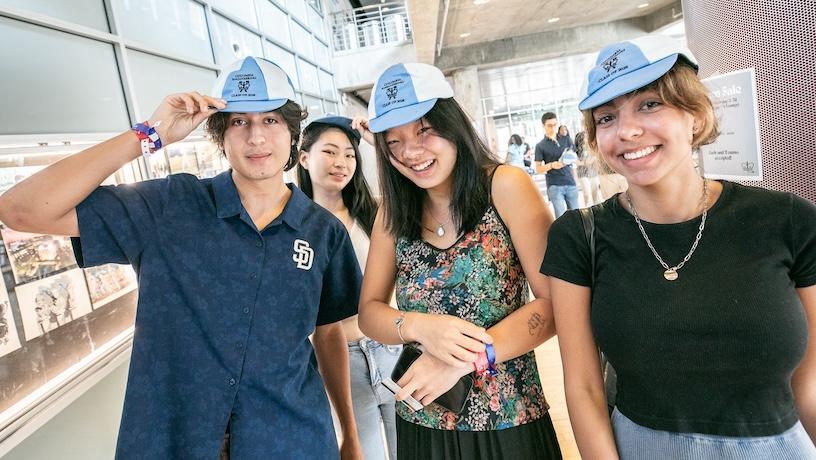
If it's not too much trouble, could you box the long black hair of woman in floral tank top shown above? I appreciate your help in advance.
[374,98,499,239]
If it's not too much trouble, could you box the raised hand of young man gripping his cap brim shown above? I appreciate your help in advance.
[149,91,226,145]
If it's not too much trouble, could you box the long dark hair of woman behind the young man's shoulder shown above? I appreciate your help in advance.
[297,123,377,237]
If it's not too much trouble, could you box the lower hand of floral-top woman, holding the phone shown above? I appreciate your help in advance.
[395,353,473,406]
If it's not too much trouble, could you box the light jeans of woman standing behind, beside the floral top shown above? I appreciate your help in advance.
[349,337,402,460]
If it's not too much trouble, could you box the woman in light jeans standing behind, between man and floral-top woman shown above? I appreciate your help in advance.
[297,116,402,460]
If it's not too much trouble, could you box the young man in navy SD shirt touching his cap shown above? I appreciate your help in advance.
[0,58,362,460]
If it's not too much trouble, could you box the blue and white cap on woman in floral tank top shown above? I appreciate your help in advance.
[368,63,453,133]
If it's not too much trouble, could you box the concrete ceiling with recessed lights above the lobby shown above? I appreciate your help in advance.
[408,0,682,71]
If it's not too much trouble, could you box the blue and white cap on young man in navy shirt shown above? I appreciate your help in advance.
[212,56,295,113]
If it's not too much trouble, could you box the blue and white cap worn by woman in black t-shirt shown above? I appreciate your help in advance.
[578,35,698,110]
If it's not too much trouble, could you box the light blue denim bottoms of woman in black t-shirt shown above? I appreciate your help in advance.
[612,409,816,460]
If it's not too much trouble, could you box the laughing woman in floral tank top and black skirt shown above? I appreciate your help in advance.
[360,64,561,460]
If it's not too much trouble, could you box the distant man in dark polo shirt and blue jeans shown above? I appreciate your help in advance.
[535,112,578,219]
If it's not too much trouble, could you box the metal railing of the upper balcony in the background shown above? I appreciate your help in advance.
[329,2,412,52]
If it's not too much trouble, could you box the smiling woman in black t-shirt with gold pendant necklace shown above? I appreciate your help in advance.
[541,36,816,460]
